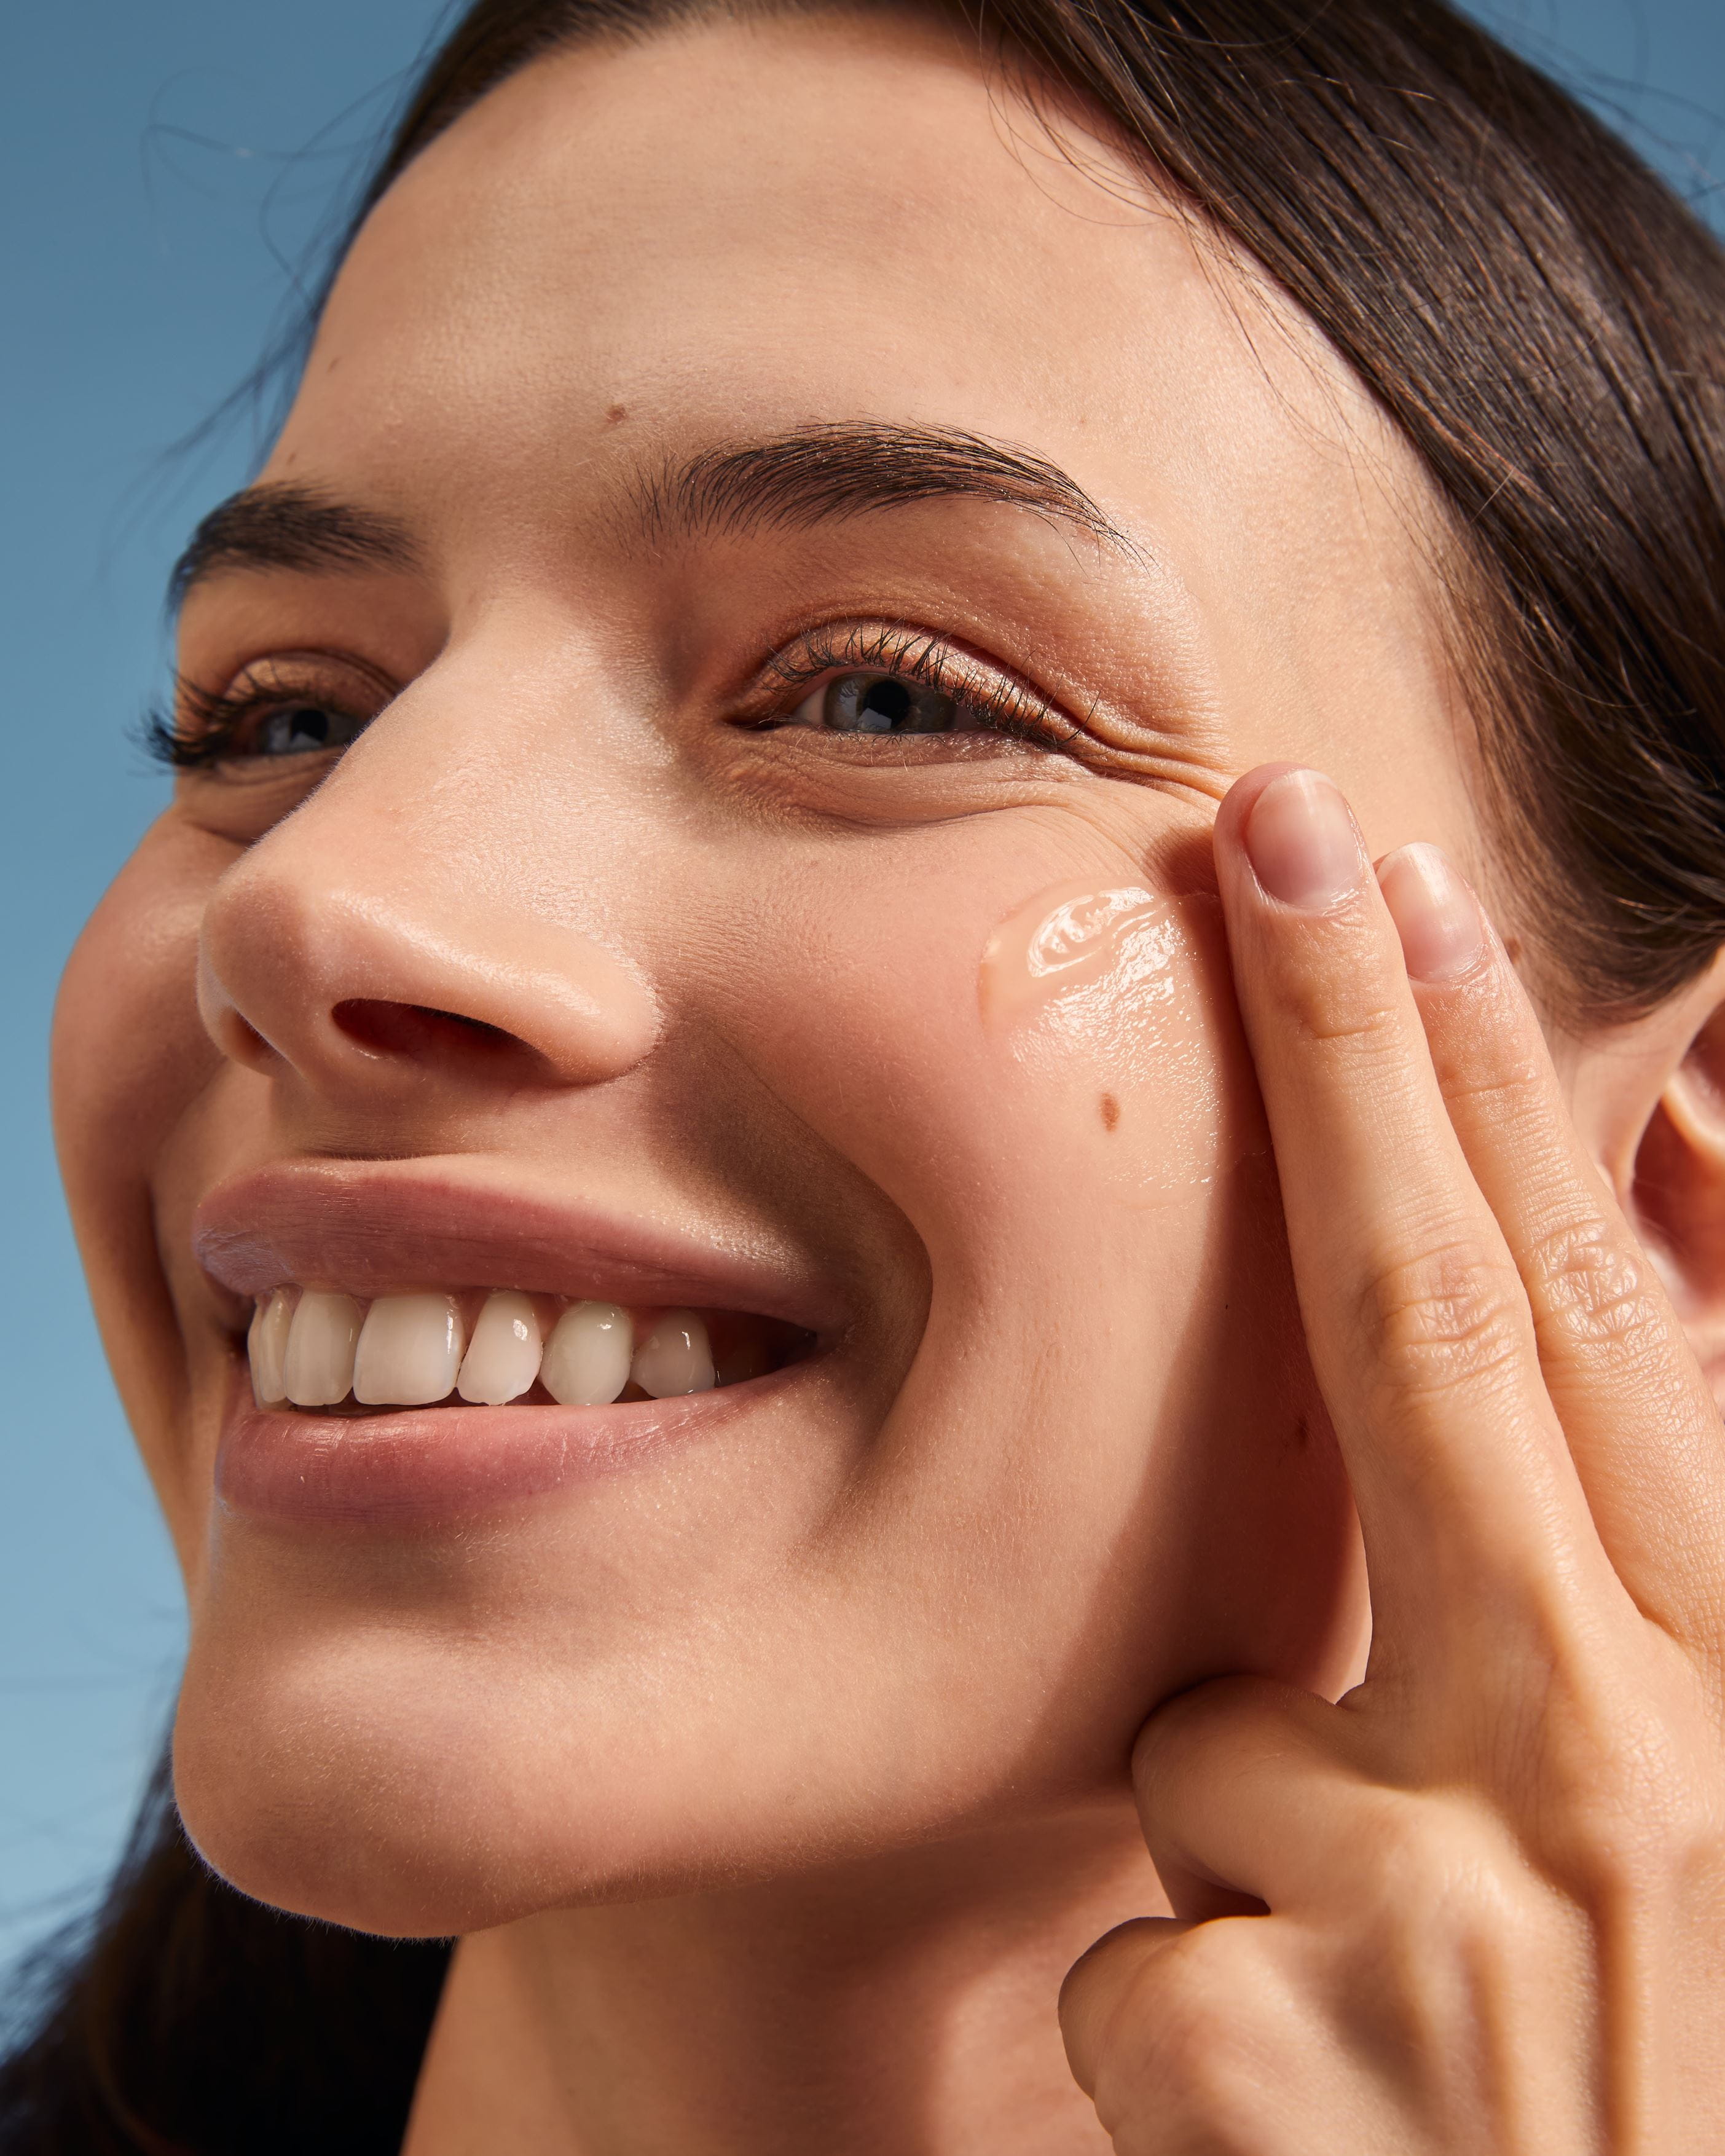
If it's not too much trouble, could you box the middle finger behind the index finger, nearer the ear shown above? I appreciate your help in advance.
[1378,845,1725,1641]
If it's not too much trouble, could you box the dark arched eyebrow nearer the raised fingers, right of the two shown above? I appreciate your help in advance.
[634,423,1139,559]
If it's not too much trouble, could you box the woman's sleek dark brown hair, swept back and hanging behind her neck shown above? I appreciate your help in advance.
[0,0,1725,2156]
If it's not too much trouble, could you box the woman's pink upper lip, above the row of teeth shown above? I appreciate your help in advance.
[192,1160,845,1332]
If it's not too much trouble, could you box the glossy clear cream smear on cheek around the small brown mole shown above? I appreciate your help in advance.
[976,884,1270,1205]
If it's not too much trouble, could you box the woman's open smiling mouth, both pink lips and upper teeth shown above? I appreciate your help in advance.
[192,1162,843,1522]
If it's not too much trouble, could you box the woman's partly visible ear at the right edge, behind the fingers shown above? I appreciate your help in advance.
[1565,951,1725,1406]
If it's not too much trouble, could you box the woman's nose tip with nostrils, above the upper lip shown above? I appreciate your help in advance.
[198,772,658,1106]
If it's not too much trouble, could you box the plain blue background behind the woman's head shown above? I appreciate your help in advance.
[0,0,1725,1960]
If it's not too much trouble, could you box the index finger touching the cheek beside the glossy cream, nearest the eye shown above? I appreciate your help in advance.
[1216,768,1609,1660]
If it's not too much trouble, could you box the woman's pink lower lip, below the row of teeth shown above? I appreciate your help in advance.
[216,1363,806,1527]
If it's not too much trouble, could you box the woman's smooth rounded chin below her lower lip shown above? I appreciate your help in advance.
[175,1624,910,1938]
